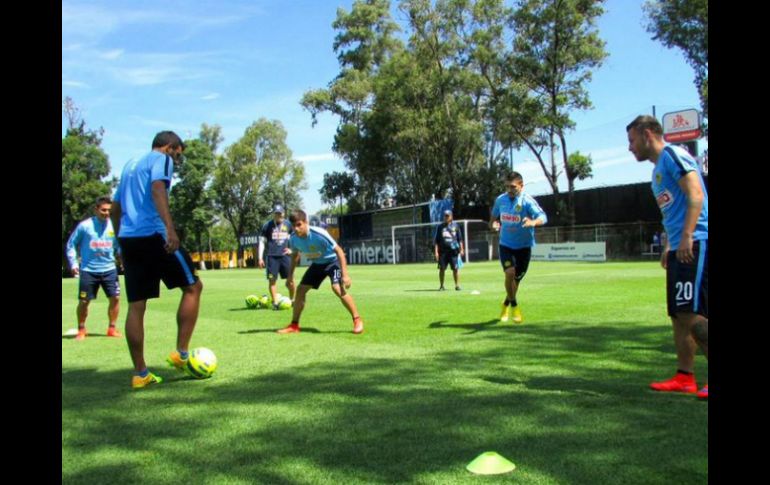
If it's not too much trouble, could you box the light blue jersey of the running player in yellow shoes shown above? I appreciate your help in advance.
[492,192,548,249]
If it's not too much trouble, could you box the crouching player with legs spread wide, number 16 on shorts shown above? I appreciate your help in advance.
[277,210,364,334]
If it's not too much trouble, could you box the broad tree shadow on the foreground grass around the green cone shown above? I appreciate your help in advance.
[62,322,708,484]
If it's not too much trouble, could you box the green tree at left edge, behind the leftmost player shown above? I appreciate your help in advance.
[61,97,116,266]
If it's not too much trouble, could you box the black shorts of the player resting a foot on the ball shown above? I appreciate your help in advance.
[118,234,198,302]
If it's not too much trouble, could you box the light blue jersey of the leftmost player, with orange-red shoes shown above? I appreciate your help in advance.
[67,216,119,273]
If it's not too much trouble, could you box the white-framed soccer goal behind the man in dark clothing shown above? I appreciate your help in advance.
[390,219,493,264]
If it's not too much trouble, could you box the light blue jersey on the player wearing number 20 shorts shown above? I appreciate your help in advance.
[652,145,709,250]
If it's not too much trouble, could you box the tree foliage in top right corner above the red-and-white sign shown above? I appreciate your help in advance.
[643,0,709,118]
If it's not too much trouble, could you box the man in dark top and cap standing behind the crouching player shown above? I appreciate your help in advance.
[257,204,296,310]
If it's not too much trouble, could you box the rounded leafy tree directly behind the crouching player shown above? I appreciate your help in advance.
[213,118,307,264]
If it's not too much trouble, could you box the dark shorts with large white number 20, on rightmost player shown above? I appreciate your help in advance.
[666,240,709,318]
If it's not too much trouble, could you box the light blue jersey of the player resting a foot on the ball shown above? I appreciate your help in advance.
[115,150,174,238]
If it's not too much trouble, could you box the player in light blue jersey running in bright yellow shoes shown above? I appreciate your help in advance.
[492,172,548,323]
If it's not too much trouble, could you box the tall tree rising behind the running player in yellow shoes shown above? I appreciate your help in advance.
[513,0,607,225]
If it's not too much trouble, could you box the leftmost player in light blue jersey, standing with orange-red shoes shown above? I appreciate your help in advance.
[67,197,122,340]
